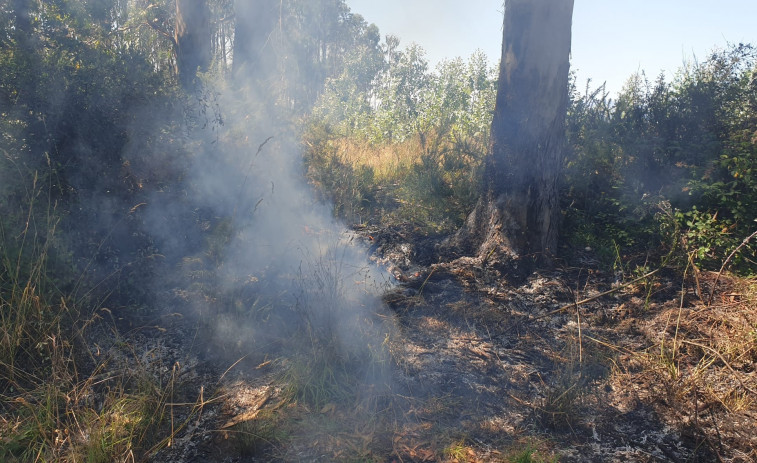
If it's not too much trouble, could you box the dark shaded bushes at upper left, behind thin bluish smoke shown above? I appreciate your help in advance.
[0,0,199,312]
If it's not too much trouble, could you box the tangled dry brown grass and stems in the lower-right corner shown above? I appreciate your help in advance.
[615,274,757,462]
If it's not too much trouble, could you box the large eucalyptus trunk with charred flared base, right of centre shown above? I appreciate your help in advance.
[452,0,573,268]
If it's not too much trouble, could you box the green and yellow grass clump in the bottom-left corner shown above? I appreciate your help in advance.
[0,300,167,462]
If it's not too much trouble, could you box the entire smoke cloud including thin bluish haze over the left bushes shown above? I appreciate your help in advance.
[0,0,392,442]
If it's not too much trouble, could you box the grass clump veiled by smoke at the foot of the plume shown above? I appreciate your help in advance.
[282,241,393,408]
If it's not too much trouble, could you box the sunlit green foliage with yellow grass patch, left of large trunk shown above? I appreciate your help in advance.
[305,47,496,232]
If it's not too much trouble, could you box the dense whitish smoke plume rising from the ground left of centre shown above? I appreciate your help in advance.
[132,2,392,398]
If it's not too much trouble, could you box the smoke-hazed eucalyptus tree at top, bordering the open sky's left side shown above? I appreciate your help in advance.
[232,0,380,112]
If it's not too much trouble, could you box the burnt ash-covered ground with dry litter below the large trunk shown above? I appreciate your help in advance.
[99,224,757,463]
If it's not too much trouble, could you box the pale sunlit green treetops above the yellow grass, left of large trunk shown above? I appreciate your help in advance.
[312,44,496,145]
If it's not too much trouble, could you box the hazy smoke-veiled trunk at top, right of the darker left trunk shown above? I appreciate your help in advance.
[231,0,281,84]
